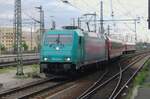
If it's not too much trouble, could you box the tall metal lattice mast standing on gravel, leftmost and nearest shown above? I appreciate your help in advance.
[14,0,24,75]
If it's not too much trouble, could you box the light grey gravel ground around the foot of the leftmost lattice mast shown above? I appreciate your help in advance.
[0,66,40,92]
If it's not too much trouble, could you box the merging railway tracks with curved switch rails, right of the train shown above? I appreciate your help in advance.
[77,54,149,99]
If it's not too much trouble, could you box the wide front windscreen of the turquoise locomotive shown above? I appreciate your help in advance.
[44,34,73,44]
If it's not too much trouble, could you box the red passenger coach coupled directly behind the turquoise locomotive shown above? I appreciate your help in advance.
[107,38,124,59]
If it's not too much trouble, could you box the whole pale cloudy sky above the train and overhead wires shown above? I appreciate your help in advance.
[0,0,150,42]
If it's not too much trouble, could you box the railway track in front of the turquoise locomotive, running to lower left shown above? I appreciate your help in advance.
[0,77,70,99]
